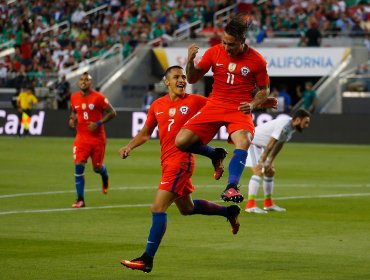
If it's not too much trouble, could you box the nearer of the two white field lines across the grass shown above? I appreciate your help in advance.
[0,193,370,215]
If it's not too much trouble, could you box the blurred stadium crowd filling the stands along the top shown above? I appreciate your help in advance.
[0,0,370,106]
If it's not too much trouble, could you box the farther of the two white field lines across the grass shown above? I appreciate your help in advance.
[0,183,370,199]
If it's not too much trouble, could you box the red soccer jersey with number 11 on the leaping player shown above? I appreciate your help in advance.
[197,44,270,106]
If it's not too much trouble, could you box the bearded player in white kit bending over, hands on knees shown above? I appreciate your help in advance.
[245,109,311,214]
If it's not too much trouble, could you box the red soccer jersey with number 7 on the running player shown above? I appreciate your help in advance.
[145,94,207,168]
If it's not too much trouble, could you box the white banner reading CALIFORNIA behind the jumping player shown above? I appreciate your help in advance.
[158,48,347,77]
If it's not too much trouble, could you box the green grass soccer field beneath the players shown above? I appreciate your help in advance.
[0,137,370,280]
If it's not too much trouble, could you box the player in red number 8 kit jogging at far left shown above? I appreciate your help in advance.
[69,72,116,208]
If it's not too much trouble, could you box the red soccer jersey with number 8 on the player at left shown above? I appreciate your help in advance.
[71,90,109,143]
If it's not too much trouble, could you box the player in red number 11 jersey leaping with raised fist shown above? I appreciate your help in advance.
[176,14,276,203]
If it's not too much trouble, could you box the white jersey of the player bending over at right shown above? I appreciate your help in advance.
[252,117,295,147]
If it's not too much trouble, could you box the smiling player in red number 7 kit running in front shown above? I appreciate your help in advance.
[119,66,240,273]
